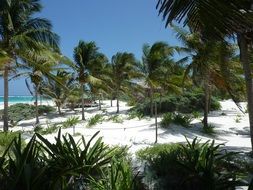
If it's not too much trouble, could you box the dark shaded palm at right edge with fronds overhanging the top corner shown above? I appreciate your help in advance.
[157,0,253,150]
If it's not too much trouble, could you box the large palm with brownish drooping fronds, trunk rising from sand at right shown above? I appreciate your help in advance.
[174,27,244,127]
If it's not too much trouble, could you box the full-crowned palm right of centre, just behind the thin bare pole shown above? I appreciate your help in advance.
[138,42,174,117]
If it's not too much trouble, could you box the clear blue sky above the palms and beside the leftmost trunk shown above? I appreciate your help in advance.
[0,0,182,95]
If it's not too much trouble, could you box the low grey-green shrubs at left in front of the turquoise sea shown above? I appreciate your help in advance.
[1,103,55,122]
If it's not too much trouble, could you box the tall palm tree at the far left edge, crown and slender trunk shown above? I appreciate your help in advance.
[0,0,59,131]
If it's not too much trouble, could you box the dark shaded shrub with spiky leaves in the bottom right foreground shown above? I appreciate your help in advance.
[137,138,242,190]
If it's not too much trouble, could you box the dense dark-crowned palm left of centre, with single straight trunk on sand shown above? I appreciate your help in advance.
[74,41,105,120]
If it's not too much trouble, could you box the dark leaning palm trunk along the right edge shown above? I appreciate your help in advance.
[238,34,253,151]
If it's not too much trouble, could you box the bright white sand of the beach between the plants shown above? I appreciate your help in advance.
[0,100,251,152]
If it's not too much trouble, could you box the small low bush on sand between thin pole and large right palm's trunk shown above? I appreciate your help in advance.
[161,112,192,128]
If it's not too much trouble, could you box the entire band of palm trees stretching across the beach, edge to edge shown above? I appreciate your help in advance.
[0,0,253,151]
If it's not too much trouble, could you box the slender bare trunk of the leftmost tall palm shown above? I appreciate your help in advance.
[3,65,9,132]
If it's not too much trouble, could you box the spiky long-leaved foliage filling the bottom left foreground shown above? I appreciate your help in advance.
[0,130,140,190]
